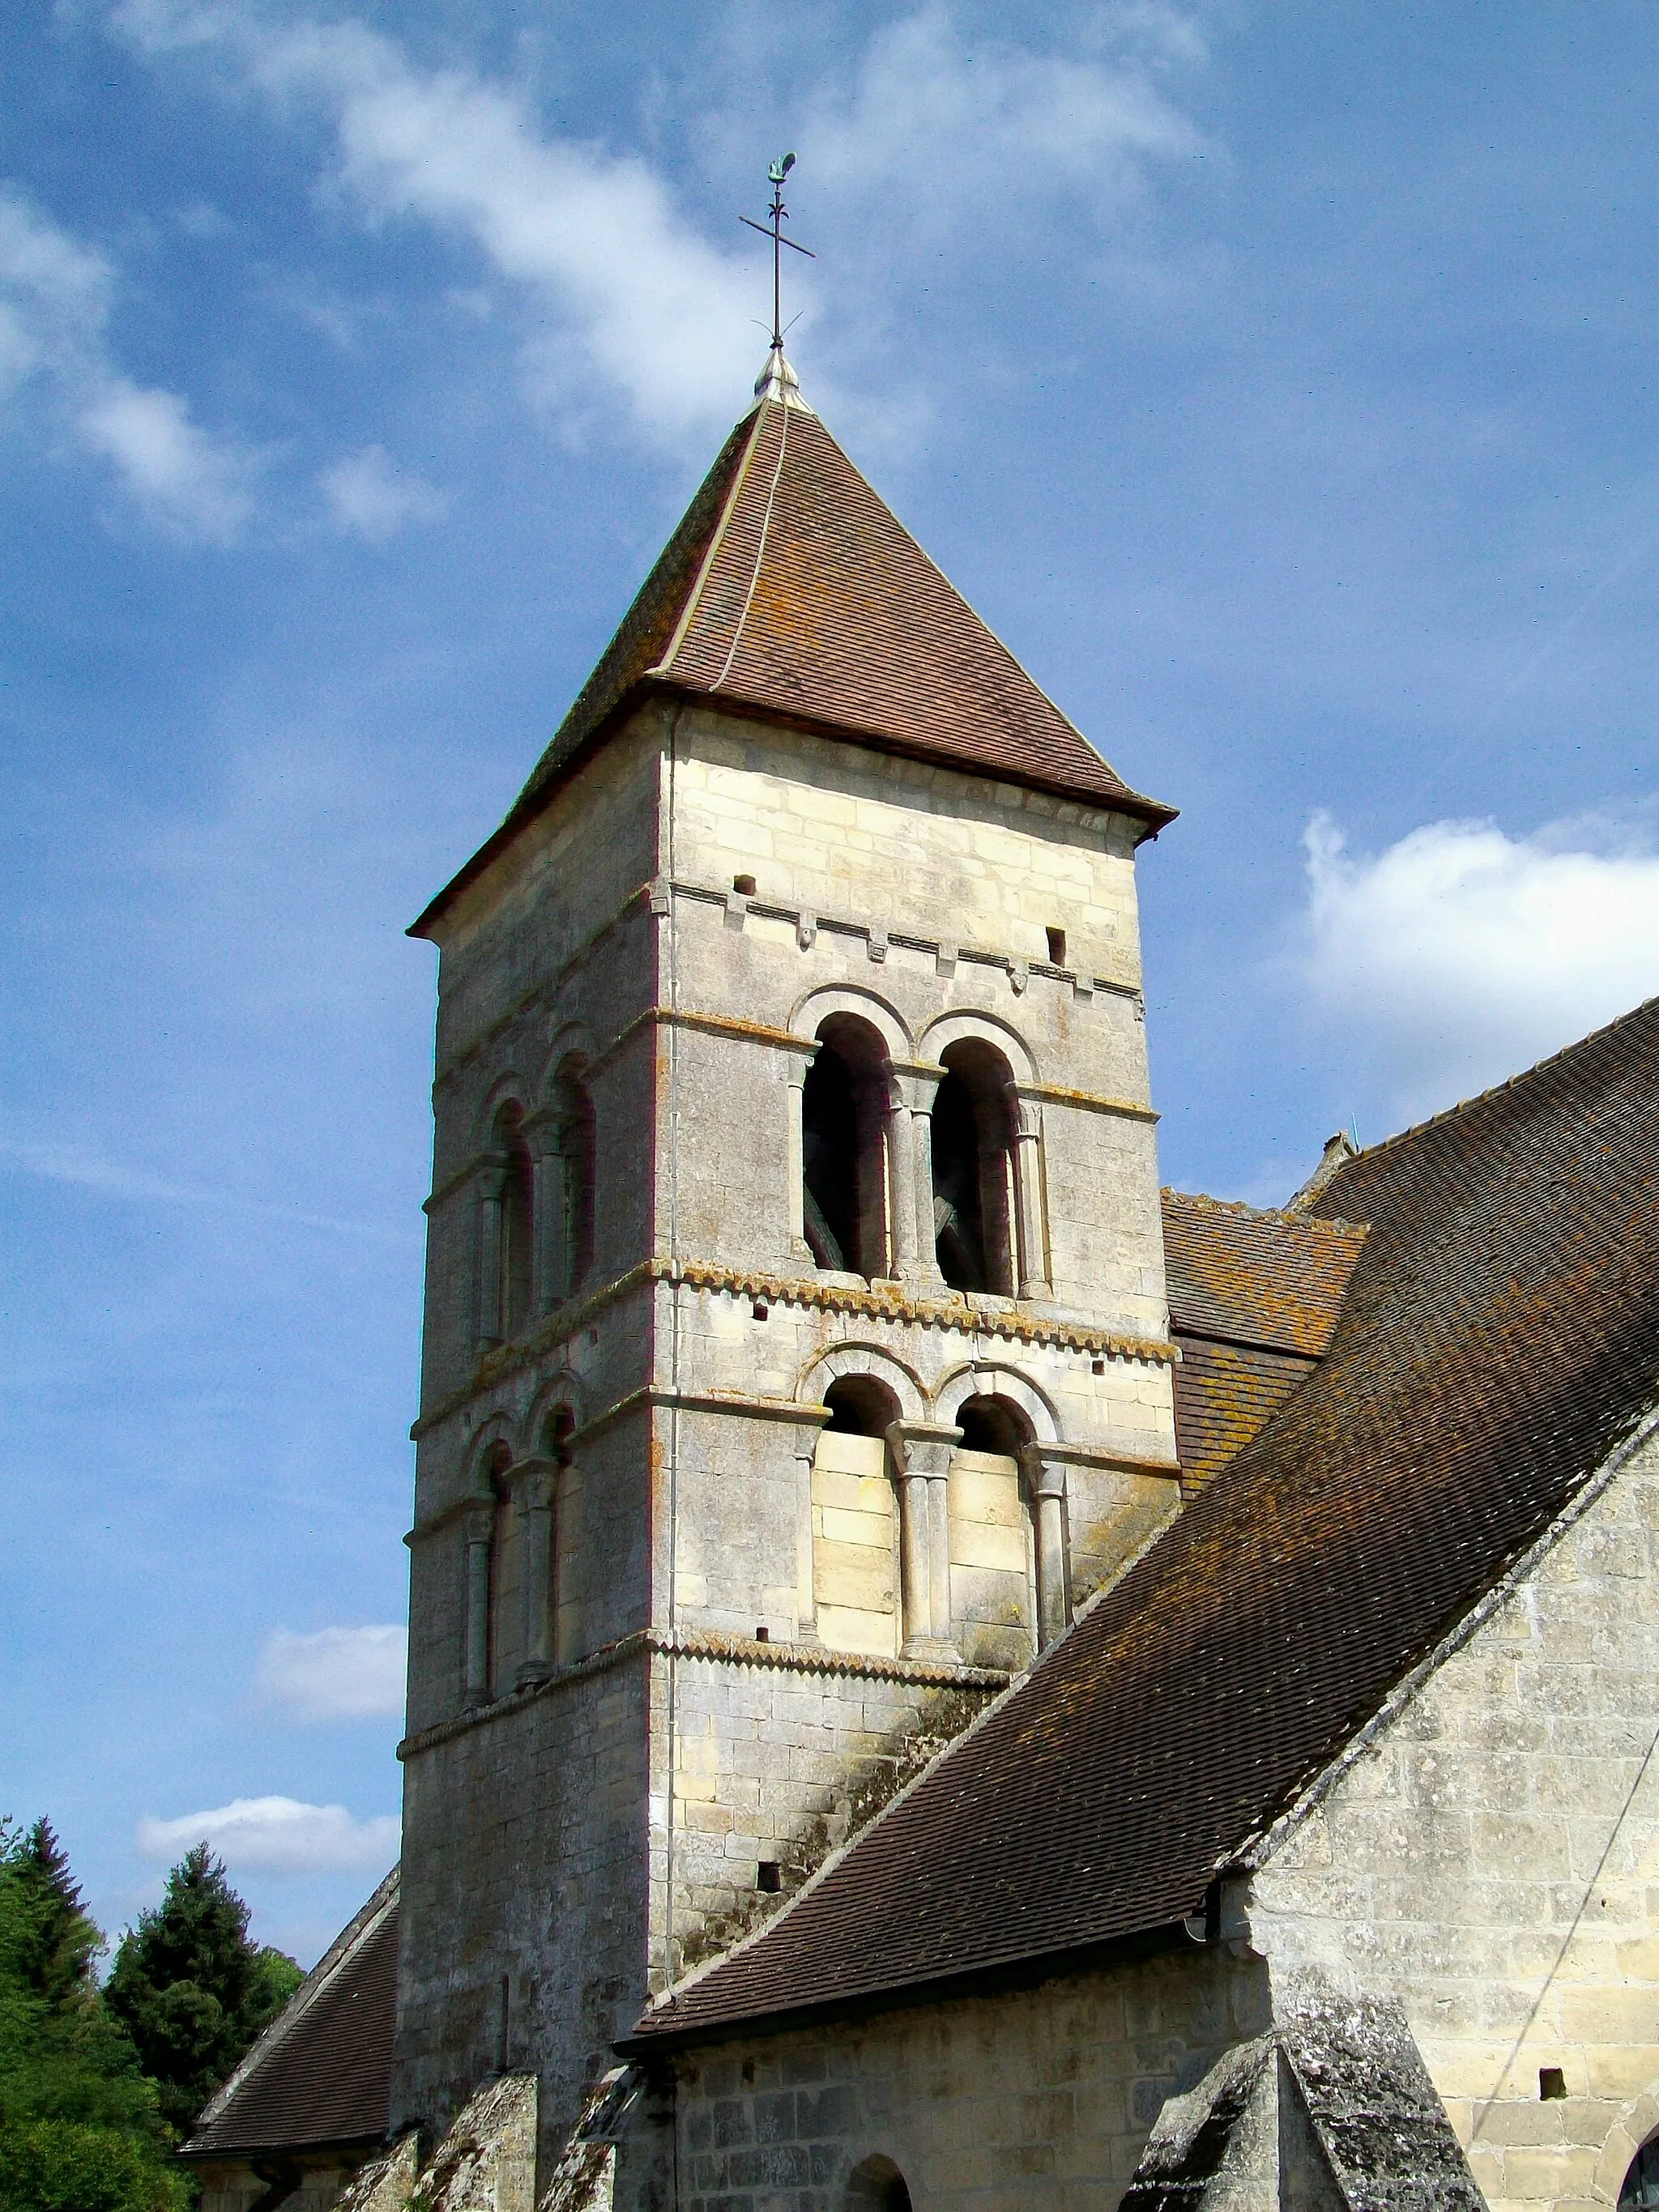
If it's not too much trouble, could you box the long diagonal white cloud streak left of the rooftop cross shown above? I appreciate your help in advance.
[113,0,757,442]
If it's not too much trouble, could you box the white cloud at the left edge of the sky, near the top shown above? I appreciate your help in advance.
[0,185,252,544]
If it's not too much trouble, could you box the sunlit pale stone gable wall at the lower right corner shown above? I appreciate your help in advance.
[1247,1440,1659,2212]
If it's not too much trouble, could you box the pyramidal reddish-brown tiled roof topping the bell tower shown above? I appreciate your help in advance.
[416,356,1175,933]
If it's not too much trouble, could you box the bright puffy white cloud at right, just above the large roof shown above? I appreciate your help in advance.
[1303,814,1659,1113]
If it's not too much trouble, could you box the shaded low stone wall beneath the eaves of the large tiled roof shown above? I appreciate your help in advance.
[663,1946,1268,2212]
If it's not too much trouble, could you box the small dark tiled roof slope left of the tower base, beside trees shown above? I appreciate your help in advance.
[181,1869,399,2159]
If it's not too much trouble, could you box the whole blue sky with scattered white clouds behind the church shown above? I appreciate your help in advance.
[0,0,1659,1960]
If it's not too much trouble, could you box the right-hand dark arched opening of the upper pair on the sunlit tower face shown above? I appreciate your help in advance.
[933,1038,1017,1296]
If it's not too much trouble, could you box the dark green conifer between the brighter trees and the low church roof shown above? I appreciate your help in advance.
[104,1843,301,2134]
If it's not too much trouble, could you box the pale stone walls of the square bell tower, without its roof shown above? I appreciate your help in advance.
[394,701,1177,2146]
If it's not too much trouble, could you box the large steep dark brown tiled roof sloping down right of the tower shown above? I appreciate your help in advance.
[637,999,1659,2037]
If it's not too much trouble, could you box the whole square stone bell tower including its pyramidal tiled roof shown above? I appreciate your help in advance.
[394,349,1177,2154]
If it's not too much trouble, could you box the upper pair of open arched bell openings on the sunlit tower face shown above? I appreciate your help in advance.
[796,1004,1048,1298]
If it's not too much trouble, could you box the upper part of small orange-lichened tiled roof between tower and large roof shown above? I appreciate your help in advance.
[1163,1190,1365,1358]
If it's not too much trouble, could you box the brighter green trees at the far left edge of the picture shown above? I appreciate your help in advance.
[0,1821,186,2212]
